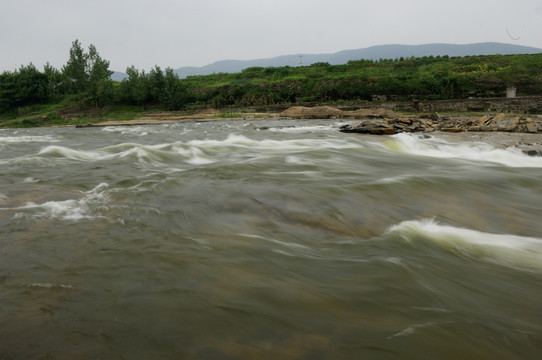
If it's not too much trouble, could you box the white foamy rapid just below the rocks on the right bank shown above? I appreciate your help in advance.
[383,133,542,168]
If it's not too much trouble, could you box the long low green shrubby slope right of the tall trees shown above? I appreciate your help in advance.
[183,54,542,107]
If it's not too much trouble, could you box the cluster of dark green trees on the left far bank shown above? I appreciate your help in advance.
[0,40,184,112]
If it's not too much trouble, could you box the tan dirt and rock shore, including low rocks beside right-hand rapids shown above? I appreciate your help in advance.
[60,106,542,156]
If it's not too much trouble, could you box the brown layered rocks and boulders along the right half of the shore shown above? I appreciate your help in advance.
[280,106,542,156]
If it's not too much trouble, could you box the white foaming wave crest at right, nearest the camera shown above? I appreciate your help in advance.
[386,220,542,270]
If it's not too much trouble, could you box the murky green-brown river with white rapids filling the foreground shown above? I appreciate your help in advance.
[0,120,542,359]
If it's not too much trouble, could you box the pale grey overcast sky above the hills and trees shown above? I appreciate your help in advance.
[0,0,542,71]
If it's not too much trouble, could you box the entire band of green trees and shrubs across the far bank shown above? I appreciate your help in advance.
[0,40,542,126]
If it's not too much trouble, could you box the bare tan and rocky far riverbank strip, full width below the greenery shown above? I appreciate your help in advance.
[0,105,542,139]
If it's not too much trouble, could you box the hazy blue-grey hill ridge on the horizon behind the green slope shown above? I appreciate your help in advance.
[112,42,542,81]
